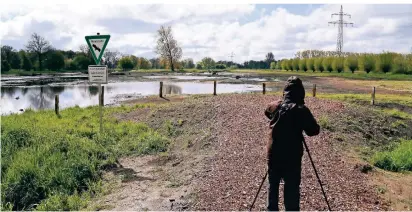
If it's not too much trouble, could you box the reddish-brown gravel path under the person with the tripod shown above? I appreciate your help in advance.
[193,94,384,211]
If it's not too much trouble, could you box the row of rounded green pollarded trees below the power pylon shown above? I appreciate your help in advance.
[279,51,412,74]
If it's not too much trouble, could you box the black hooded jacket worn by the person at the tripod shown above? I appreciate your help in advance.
[265,77,320,160]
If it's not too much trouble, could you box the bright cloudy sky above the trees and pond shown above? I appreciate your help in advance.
[0,3,412,62]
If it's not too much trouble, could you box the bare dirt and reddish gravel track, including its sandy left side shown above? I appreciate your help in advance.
[99,94,386,211]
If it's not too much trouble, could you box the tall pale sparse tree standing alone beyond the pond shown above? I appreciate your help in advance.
[156,26,182,71]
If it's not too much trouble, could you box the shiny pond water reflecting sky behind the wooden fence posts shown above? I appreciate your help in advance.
[1,82,262,114]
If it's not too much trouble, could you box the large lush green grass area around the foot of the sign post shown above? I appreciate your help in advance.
[1,105,169,211]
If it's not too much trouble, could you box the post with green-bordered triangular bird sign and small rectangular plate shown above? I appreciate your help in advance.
[85,33,110,133]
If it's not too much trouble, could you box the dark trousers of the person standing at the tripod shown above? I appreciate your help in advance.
[267,158,302,211]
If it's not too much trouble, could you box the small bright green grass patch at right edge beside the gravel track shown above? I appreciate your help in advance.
[372,140,412,172]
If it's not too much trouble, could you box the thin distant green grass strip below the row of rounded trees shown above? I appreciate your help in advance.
[230,69,412,80]
